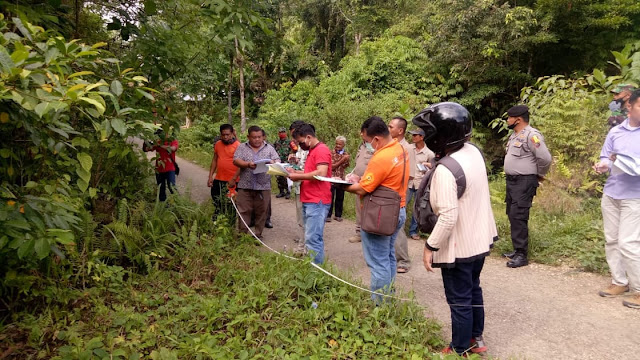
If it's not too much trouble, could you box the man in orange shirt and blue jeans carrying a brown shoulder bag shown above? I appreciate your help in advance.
[345,116,410,302]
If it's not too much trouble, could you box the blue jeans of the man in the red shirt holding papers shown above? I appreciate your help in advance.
[302,201,331,265]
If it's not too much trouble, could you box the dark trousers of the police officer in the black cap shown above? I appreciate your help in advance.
[505,175,538,256]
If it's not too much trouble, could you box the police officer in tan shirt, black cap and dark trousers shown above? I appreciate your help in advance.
[504,105,551,268]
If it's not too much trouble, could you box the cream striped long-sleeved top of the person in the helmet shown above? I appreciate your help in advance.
[427,144,498,267]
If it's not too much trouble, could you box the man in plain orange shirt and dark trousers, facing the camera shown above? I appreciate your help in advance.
[207,124,240,219]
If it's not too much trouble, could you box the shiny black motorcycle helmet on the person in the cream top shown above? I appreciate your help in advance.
[413,102,473,158]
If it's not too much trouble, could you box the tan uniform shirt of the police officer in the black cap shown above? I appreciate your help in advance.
[504,125,552,176]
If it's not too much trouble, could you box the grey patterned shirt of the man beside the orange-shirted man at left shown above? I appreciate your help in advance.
[233,142,280,190]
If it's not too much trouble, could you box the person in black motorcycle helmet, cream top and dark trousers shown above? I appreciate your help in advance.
[413,102,498,355]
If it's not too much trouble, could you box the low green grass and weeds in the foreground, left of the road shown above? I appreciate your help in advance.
[0,205,444,359]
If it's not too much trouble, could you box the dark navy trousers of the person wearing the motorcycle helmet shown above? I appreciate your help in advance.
[442,258,484,354]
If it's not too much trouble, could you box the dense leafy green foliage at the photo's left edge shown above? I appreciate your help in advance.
[0,14,162,272]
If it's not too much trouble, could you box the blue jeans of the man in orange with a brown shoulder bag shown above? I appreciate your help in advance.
[360,208,407,303]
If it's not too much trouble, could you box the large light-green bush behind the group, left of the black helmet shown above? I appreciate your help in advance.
[258,36,462,150]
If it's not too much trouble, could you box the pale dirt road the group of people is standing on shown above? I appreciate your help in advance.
[178,155,640,359]
